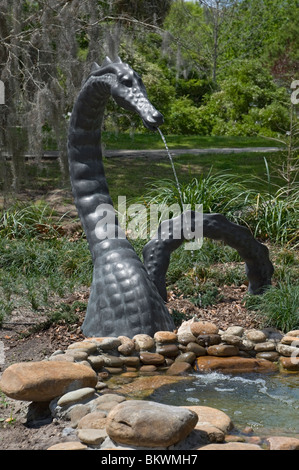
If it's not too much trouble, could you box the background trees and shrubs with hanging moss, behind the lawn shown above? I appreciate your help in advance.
[0,0,299,193]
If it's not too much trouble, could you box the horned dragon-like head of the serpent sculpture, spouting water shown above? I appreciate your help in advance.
[91,57,164,130]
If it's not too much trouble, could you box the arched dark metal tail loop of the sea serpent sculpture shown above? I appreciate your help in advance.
[143,211,274,301]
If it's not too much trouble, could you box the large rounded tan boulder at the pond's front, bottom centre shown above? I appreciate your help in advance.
[106,400,198,447]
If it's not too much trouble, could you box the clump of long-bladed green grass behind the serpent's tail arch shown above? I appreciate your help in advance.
[143,167,299,246]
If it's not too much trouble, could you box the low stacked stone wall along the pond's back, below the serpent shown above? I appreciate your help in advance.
[49,319,299,379]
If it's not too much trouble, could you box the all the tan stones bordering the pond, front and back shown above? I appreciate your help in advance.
[0,319,299,450]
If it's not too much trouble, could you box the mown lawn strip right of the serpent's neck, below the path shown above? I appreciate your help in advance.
[104,153,282,203]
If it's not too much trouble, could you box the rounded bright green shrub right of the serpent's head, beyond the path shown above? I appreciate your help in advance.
[201,60,290,136]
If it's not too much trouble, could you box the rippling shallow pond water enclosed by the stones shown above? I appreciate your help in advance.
[150,372,299,438]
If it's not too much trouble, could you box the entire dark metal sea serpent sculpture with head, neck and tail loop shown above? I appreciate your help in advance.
[68,58,273,338]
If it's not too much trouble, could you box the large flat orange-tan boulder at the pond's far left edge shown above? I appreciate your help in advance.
[0,361,97,402]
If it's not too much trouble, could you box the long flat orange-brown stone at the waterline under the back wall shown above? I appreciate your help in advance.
[194,356,277,373]
